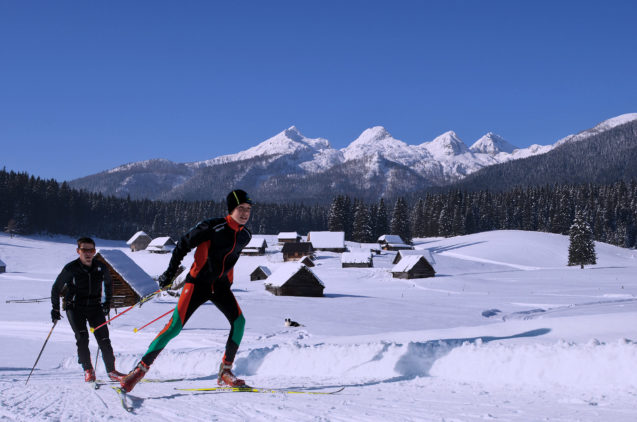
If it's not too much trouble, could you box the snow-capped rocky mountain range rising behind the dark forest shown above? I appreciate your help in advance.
[70,114,637,203]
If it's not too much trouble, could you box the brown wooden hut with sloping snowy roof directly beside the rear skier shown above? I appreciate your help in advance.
[95,249,159,308]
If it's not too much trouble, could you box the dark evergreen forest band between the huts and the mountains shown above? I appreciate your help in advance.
[0,169,637,247]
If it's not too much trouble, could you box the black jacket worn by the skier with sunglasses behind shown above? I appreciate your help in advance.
[51,258,113,311]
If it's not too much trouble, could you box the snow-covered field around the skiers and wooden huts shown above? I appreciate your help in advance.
[0,231,637,422]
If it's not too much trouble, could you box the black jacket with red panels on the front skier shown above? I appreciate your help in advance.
[168,215,252,288]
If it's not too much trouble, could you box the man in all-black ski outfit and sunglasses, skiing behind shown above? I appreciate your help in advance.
[51,237,124,382]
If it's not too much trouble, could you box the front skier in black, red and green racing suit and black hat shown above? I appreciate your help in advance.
[121,189,252,391]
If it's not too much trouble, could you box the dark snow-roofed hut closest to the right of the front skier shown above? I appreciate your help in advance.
[265,262,325,297]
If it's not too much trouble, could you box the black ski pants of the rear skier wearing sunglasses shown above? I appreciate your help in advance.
[66,305,115,372]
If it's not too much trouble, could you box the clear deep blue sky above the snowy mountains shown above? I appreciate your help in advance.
[0,0,637,181]
